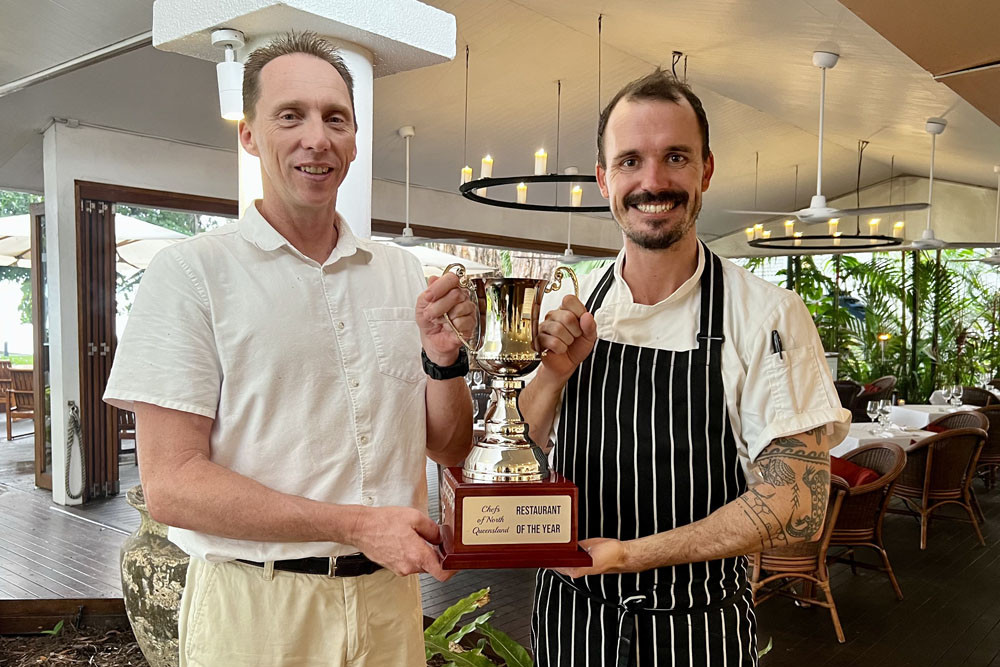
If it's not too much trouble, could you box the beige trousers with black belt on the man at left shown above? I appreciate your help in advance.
[179,558,427,667]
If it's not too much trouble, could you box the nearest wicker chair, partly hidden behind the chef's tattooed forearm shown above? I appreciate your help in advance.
[748,475,848,644]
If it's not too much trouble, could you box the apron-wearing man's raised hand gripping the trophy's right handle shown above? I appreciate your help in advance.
[538,294,597,381]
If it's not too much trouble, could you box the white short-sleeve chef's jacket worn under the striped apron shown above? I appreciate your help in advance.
[542,243,851,469]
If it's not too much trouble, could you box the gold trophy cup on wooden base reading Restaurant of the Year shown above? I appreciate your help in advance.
[441,264,591,570]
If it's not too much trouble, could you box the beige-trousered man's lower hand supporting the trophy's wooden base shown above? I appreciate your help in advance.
[351,507,454,581]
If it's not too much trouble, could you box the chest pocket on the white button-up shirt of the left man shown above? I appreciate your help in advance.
[364,308,424,383]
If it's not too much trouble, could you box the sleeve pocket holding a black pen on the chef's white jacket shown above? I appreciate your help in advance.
[764,345,829,419]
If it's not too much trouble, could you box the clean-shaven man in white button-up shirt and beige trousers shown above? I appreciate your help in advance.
[105,33,474,667]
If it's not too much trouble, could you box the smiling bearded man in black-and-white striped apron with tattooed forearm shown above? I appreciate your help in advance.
[521,70,850,667]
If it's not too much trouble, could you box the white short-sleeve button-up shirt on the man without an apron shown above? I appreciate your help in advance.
[104,206,427,561]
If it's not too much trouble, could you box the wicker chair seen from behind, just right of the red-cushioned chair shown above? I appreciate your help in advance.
[889,430,988,549]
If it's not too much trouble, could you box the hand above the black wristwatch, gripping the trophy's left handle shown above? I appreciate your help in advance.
[416,273,476,366]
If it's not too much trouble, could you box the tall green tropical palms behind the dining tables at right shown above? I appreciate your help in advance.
[744,249,1000,402]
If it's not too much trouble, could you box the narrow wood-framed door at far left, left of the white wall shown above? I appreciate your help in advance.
[29,204,52,491]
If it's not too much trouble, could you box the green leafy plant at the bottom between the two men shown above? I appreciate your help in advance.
[424,588,535,667]
